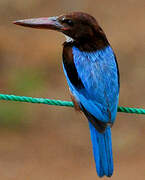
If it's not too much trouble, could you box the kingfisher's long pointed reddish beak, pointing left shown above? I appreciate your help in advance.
[13,17,63,31]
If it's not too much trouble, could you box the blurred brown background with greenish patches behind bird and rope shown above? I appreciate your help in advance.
[0,0,145,180]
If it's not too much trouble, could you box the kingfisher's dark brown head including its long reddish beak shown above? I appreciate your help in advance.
[14,12,108,49]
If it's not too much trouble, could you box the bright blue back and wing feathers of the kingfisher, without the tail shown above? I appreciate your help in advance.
[64,46,119,122]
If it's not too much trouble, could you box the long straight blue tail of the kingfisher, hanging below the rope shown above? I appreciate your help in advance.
[89,122,113,177]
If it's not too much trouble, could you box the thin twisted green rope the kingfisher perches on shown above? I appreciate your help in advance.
[0,94,145,114]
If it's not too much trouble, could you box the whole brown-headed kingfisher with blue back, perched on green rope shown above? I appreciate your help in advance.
[14,12,120,177]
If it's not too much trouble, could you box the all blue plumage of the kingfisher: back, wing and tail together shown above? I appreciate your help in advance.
[63,46,119,177]
